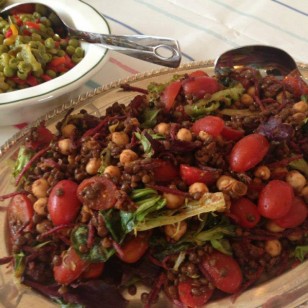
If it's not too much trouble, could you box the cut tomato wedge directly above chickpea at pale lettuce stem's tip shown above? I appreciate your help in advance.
[180,165,219,185]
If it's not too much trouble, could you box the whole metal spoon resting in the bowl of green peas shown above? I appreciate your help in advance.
[0,2,181,67]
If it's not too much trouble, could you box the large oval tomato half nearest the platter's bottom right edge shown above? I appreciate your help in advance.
[201,250,243,293]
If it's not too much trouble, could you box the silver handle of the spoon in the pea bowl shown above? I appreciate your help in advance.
[69,28,181,67]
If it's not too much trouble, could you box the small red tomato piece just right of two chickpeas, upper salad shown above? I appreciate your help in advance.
[191,116,225,137]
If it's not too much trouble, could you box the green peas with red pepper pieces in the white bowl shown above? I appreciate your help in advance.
[0,4,84,93]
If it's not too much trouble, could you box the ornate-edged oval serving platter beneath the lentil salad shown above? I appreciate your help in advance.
[0,61,308,308]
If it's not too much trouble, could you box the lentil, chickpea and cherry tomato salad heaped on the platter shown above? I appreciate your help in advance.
[0,63,308,307]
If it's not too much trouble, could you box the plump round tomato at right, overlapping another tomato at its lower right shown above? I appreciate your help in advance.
[258,180,294,219]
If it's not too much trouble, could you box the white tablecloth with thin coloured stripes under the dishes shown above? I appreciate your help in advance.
[0,0,308,145]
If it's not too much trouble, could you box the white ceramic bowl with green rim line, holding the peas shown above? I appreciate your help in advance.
[0,0,110,125]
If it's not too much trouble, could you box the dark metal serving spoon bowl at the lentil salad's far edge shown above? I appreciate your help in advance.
[214,45,299,78]
